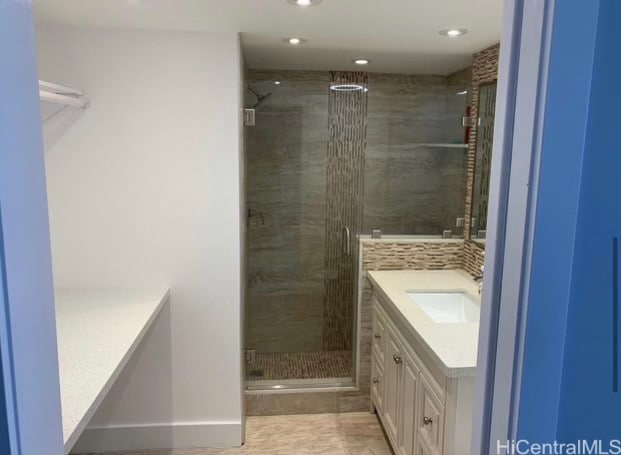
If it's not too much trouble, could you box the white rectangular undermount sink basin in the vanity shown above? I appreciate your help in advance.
[408,291,480,324]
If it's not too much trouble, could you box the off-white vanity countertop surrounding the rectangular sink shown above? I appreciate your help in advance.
[368,270,481,377]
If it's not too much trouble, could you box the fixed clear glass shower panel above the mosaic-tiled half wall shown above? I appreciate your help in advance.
[362,71,470,236]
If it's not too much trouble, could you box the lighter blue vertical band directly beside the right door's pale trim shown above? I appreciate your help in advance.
[518,0,598,441]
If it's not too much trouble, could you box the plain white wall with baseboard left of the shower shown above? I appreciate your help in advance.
[37,27,243,450]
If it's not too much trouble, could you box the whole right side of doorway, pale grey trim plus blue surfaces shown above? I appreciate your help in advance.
[470,0,621,455]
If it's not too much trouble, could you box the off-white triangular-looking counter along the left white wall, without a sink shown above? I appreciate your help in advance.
[55,288,169,453]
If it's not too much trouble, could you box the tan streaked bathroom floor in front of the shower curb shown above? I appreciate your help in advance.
[80,412,392,455]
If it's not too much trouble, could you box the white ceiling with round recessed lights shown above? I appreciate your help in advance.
[33,0,503,74]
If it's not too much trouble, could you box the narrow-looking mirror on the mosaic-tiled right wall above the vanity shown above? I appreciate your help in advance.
[470,82,496,244]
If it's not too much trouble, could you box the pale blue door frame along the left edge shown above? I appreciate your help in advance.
[0,0,64,455]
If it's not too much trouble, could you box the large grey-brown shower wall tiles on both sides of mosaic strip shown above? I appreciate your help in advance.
[246,71,467,352]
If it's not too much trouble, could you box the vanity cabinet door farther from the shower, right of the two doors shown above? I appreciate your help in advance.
[398,348,420,455]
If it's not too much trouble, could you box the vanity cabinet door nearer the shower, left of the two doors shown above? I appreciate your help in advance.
[384,326,403,444]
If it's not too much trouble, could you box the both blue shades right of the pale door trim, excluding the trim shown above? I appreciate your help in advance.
[517,0,621,445]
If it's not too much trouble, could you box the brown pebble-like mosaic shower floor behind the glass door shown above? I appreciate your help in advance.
[246,351,353,382]
